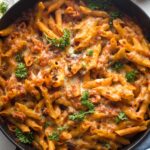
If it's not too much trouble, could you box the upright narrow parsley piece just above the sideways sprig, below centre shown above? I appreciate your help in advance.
[81,91,94,110]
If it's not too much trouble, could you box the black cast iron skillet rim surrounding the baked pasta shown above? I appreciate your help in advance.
[0,0,150,150]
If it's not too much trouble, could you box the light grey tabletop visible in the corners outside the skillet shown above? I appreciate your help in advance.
[0,0,150,150]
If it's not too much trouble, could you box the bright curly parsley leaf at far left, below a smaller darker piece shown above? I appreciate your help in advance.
[15,63,28,79]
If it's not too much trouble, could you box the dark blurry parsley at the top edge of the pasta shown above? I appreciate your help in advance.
[85,0,111,10]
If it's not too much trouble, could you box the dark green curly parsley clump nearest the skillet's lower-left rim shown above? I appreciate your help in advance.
[15,128,34,144]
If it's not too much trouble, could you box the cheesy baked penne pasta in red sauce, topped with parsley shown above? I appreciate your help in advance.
[0,0,150,150]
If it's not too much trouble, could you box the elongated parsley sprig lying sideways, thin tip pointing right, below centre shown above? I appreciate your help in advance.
[69,110,94,121]
